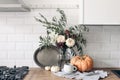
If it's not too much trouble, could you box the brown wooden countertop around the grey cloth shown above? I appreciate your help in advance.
[24,68,120,80]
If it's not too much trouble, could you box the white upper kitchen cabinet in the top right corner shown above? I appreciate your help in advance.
[83,0,120,25]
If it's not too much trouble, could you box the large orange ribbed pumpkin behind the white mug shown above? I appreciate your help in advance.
[70,55,93,72]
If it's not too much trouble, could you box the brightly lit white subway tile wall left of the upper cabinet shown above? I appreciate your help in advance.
[0,9,79,67]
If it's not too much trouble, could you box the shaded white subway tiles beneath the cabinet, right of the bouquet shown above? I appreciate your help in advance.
[85,26,120,67]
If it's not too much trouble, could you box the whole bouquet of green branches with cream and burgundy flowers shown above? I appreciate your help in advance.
[35,9,88,60]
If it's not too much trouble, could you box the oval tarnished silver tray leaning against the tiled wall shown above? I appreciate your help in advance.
[34,46,60,68]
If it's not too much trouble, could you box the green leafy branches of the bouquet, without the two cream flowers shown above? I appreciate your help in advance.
[35,8,89,54]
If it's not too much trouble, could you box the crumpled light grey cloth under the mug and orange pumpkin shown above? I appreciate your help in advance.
[53,70,108,80]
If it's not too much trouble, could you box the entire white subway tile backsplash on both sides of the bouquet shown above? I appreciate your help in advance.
[0,9,120,67]
